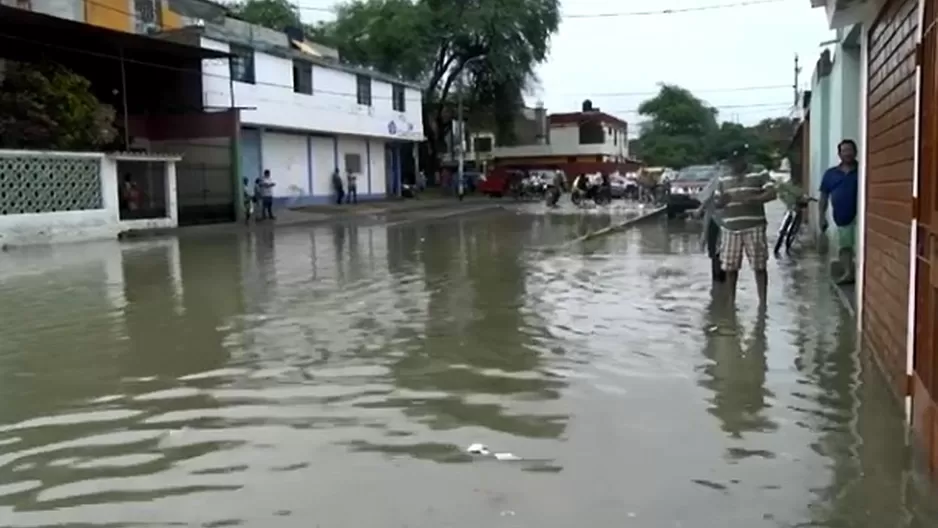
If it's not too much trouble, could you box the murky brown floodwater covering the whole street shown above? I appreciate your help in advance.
[0,205,938,528]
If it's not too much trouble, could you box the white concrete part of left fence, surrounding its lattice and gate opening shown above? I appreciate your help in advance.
[0,150,177,246]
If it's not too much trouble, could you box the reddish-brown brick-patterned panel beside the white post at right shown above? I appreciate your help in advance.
[863,0,918,397]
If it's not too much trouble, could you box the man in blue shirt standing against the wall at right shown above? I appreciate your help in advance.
[818,139,859,284]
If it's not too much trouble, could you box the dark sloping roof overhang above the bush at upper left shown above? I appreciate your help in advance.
[0,5,230,59]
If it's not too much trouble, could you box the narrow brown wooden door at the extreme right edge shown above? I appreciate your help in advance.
[911,0,938,475]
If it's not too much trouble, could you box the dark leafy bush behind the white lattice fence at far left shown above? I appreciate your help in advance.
[0,62,117,150]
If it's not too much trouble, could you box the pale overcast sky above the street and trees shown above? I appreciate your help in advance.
[298,0,833,133]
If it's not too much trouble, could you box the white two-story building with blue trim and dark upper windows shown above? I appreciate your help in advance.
[199,19,424,205]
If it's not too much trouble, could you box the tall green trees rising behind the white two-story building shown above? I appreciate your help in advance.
[233,0,560,170]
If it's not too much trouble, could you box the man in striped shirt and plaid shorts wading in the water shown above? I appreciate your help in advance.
[715,145,775,307]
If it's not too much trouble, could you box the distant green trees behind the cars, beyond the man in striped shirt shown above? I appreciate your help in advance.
[634,84,796,168]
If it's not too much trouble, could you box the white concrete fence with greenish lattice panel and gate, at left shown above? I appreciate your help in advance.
[0,150,180,246]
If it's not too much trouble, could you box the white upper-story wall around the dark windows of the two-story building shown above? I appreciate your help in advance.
[202,38,424,141]
